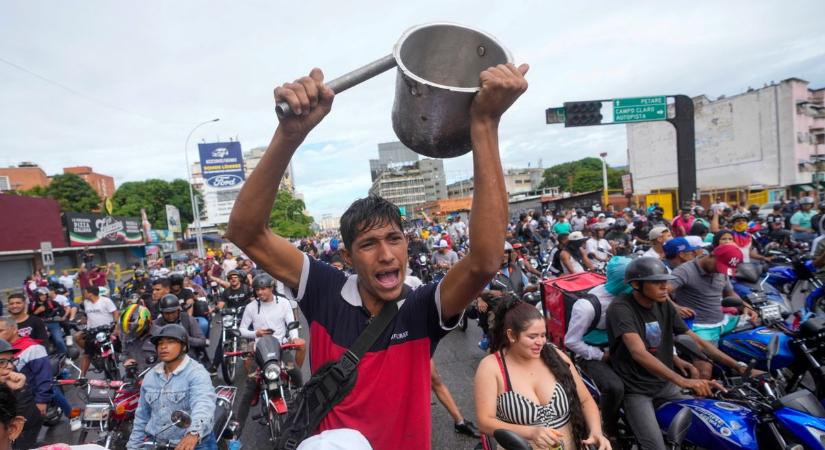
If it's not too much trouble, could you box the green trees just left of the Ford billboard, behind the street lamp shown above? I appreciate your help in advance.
[112,179,203,230]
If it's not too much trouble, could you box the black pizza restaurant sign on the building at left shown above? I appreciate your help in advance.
[64,213,143,247]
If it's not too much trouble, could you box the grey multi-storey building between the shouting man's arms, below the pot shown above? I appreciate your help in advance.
[369,142,447,214]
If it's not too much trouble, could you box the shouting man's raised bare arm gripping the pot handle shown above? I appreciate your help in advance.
[225,68,335,289]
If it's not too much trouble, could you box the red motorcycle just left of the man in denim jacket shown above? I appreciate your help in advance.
[74,364,152,449]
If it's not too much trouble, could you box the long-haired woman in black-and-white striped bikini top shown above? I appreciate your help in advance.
[474,300,610,450]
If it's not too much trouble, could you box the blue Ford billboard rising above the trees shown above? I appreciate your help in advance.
[198,142,244,189]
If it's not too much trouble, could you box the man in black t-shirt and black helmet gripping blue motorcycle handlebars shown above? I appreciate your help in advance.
[607,257,747,450]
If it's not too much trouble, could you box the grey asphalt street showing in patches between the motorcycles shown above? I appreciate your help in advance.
[41,312,484,450]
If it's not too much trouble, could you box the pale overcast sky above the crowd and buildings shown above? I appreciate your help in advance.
[0,0,825,219]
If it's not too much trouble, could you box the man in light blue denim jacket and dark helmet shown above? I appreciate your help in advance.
[126,324,218,450]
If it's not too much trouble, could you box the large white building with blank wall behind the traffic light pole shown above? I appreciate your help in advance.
[627,78,825,193]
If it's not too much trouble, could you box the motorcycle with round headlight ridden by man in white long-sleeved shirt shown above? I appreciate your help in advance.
[225,322,303,442]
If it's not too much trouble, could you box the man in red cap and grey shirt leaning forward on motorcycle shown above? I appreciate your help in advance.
[670,244,755,378]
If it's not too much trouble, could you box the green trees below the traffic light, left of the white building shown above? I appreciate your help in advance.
[541,158,627,193]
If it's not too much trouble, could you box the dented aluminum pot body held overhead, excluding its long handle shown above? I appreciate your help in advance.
[392,23,513,158]
